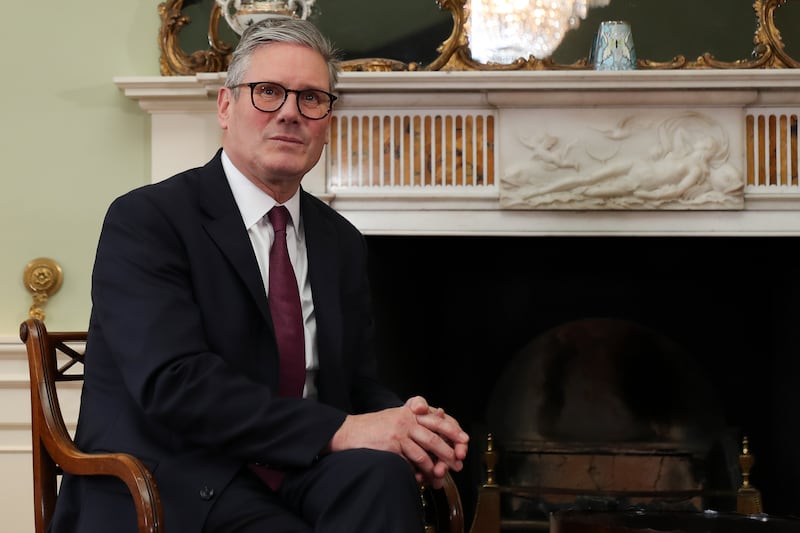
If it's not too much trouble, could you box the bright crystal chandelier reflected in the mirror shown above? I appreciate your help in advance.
[467,0,611,64]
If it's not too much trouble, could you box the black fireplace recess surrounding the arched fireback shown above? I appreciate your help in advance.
[367,236,800,524]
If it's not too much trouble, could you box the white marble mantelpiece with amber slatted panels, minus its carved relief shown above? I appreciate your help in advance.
[114,69,800,236]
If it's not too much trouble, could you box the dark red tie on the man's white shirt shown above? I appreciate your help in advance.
[267,205,306,397]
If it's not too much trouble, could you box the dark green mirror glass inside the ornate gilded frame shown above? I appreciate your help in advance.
[180,0,800,65]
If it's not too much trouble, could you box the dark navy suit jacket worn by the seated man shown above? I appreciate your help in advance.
[54,152,401,533]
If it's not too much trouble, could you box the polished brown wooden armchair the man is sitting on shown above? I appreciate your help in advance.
[19,318,464,533]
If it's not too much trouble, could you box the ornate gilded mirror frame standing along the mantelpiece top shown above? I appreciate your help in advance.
[158,0,800,76]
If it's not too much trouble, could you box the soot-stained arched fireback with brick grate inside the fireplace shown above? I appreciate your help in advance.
[484,319,740,530]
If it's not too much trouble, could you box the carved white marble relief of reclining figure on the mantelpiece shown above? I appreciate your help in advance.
[500,111,744,209]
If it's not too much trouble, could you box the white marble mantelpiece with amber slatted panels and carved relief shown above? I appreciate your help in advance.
[115,69,800,236]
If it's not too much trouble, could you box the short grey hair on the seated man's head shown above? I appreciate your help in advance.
[225,17,339,91]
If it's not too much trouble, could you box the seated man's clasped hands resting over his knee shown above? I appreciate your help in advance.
[330,396,469,488]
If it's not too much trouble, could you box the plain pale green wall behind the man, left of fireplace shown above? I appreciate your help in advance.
[0,0,161,336]
